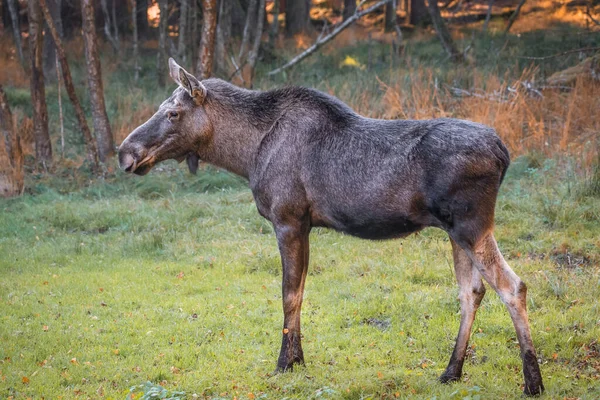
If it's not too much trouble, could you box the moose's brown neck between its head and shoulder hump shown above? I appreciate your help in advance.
[198,79,277,179]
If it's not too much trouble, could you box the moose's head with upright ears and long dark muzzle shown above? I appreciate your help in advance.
[119,58,207,175]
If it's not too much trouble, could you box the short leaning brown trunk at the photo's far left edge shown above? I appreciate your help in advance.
[0,84,25,197]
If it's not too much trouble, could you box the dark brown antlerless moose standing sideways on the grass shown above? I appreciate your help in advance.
[119,59,544,395]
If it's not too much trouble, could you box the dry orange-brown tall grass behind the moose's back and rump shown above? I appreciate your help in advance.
[381,69,600,168]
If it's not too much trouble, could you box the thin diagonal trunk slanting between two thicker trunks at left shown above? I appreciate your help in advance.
[39,0,100,173]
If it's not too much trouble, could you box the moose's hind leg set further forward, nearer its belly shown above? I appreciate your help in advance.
[440,239,485,383]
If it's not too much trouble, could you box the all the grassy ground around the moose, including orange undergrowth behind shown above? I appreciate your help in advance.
[0,7,600,399]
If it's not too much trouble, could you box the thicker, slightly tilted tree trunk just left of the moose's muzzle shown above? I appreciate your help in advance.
[81,0,115,163]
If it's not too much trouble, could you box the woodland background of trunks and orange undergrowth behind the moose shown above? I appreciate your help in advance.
[0,0,600,197]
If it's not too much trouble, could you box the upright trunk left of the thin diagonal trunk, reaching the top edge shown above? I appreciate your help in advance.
[28,0,52,170]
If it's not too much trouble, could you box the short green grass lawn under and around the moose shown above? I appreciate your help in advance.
[0,158,600,399]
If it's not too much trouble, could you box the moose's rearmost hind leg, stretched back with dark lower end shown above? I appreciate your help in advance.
[467,232,544,396]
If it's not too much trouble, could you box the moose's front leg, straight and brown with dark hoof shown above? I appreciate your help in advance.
[275,222,310,372]
